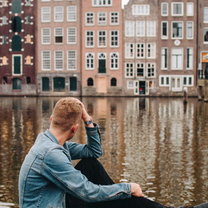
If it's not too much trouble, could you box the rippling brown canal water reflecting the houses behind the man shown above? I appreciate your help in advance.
[0,98,208,207]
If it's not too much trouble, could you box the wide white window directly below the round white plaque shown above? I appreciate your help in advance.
[171,48,183,70]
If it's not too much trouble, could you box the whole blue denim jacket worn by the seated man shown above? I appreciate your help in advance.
[19,126,131,208]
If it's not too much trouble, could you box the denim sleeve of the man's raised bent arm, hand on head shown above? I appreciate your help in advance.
[65,124,102,160]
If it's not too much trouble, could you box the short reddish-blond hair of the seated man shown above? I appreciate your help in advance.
[51,97,82,131]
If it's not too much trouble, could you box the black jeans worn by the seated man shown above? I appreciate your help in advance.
[66,158,165,208]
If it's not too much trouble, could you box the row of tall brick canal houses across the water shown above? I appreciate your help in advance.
[0,0,208,96]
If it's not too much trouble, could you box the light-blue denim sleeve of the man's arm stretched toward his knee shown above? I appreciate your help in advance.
[41,148,131,202]
